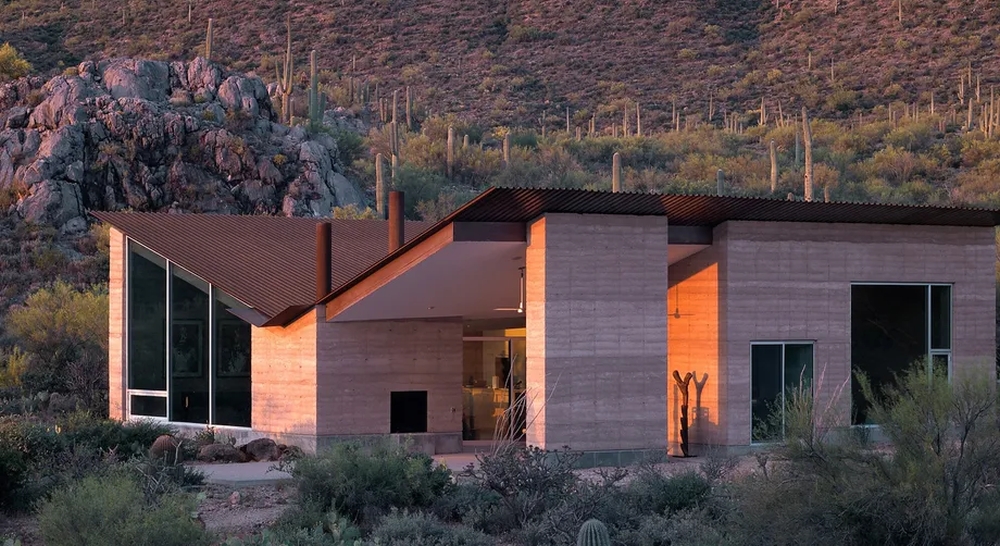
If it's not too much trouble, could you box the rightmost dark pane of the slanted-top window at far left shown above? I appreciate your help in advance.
[214,290,251,427]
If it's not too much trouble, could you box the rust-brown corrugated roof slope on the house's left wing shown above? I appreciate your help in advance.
[92,212,431,317]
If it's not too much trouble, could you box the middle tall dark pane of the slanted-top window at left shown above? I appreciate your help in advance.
[170,267,210,423]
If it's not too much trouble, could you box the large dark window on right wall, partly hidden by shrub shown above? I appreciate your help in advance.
[851,284,952,424]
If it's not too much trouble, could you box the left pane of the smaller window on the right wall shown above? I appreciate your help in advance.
[750,345,784,442]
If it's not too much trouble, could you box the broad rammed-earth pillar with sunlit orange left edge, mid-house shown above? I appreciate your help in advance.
[525,214,667,451]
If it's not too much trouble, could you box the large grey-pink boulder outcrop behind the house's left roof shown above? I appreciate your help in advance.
[0,53,363,227]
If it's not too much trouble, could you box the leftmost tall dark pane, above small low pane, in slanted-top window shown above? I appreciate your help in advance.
[128,242,167,391]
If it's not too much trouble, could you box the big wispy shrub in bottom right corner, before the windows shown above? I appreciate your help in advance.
[728,363,1000,545]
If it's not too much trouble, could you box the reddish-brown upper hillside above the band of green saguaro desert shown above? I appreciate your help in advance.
[0,0,1000,130]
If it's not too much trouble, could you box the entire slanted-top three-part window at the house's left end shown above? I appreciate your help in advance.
[126,241,252,427]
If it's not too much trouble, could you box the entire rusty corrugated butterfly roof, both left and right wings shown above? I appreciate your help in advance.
[92,188,1000,326]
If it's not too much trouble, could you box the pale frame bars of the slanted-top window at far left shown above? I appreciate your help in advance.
[122,236,253,430]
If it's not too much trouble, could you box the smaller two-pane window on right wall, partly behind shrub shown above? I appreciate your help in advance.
[750,342,813,442]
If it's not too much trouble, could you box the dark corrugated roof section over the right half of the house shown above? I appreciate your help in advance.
[447,188,1000,226]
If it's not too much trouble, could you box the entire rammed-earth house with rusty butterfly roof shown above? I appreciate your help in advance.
[95,189,1000,462]
